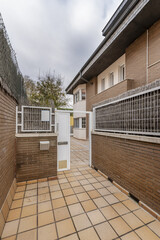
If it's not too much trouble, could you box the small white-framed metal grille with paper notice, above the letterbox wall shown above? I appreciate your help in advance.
[17,106,55,132]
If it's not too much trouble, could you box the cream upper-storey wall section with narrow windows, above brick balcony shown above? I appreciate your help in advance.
[97,54,125,93]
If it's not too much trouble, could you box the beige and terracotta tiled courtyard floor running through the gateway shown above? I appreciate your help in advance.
[2,139,160,240]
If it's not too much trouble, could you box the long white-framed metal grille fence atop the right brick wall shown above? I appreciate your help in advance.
[94,87,160,136]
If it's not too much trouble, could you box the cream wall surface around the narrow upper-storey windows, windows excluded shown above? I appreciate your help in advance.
[98,54,125,93]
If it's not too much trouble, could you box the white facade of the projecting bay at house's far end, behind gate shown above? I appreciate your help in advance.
[73,84,86,140]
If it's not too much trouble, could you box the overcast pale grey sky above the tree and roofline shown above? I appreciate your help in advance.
[0,0,121,87]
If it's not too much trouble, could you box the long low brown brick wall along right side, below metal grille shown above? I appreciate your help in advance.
[92,134,160,213]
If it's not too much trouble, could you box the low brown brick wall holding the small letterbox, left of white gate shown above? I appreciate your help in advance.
[16,135,57,181]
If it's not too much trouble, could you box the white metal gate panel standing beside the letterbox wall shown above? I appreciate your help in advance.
[56,111,70,171]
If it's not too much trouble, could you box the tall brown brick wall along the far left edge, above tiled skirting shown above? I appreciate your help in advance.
[0,87,16,208]
